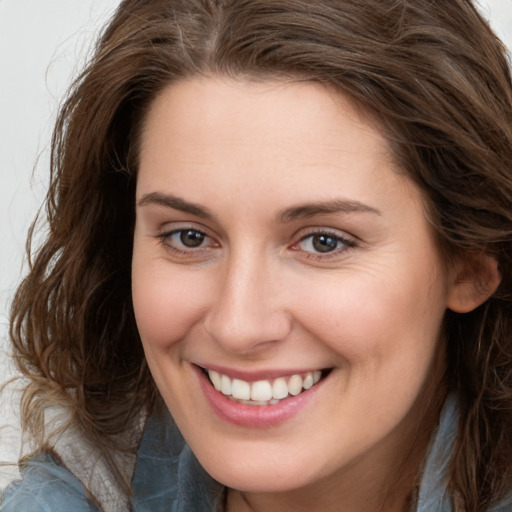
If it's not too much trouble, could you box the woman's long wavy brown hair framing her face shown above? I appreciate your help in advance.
[11,0,512,512]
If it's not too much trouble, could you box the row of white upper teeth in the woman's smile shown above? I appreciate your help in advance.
[208,370,322,403]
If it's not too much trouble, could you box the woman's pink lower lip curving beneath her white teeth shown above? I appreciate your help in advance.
[194,367,325,428]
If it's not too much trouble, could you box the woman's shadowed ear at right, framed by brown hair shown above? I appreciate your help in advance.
[446,254,501,313]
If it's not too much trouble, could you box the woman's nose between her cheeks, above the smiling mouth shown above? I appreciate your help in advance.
[205,251,292,354]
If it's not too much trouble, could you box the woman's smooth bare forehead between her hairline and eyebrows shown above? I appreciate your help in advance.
[136,78,393,192]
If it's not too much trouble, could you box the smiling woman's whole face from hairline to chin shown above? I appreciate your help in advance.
[133,78,453,498]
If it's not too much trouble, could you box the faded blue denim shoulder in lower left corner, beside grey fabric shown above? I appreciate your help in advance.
[0,452,100,512]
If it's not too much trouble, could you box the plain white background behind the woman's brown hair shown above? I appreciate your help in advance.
[0,0,512,488]
